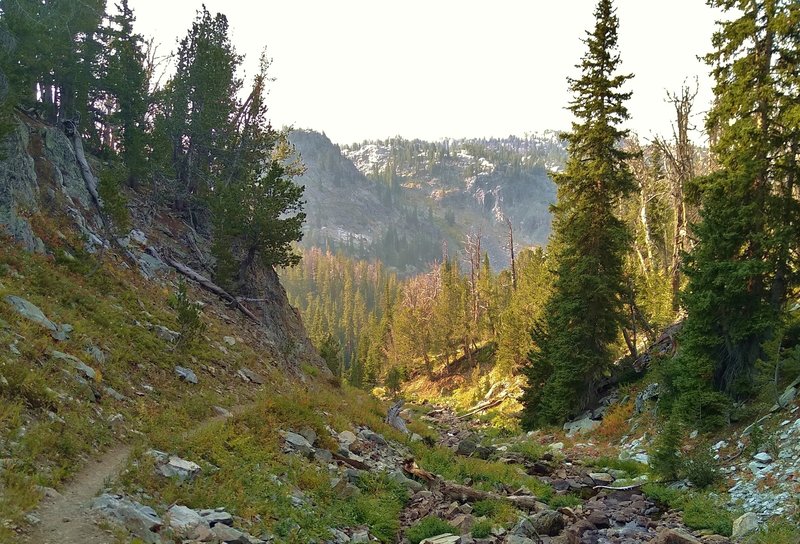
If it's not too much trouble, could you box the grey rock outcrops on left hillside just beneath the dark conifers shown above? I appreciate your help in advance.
[0,112,327,373]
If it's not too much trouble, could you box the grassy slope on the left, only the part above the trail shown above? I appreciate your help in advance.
[0,225,288,541]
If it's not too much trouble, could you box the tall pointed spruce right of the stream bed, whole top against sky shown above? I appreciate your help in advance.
[523,0,635,428]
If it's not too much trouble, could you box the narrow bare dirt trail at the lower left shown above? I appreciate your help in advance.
[28,445,131,544]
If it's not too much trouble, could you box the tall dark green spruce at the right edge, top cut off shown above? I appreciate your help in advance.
[672,0,800,427]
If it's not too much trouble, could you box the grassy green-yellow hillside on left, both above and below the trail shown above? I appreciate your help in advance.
[0,230,550,543]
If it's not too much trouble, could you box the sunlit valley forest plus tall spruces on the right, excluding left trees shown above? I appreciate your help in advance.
[288,1,800,434]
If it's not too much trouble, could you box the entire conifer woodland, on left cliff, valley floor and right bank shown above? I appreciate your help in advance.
[0,0,800,438]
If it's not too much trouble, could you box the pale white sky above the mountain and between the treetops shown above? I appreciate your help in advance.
[130,0,720,144]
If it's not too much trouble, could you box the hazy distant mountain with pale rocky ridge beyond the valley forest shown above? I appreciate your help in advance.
[290,131,565,271]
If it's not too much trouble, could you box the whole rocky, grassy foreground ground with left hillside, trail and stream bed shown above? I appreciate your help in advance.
[0,111,800,544]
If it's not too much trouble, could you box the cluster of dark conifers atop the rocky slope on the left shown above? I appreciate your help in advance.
[0,0,305,291]
